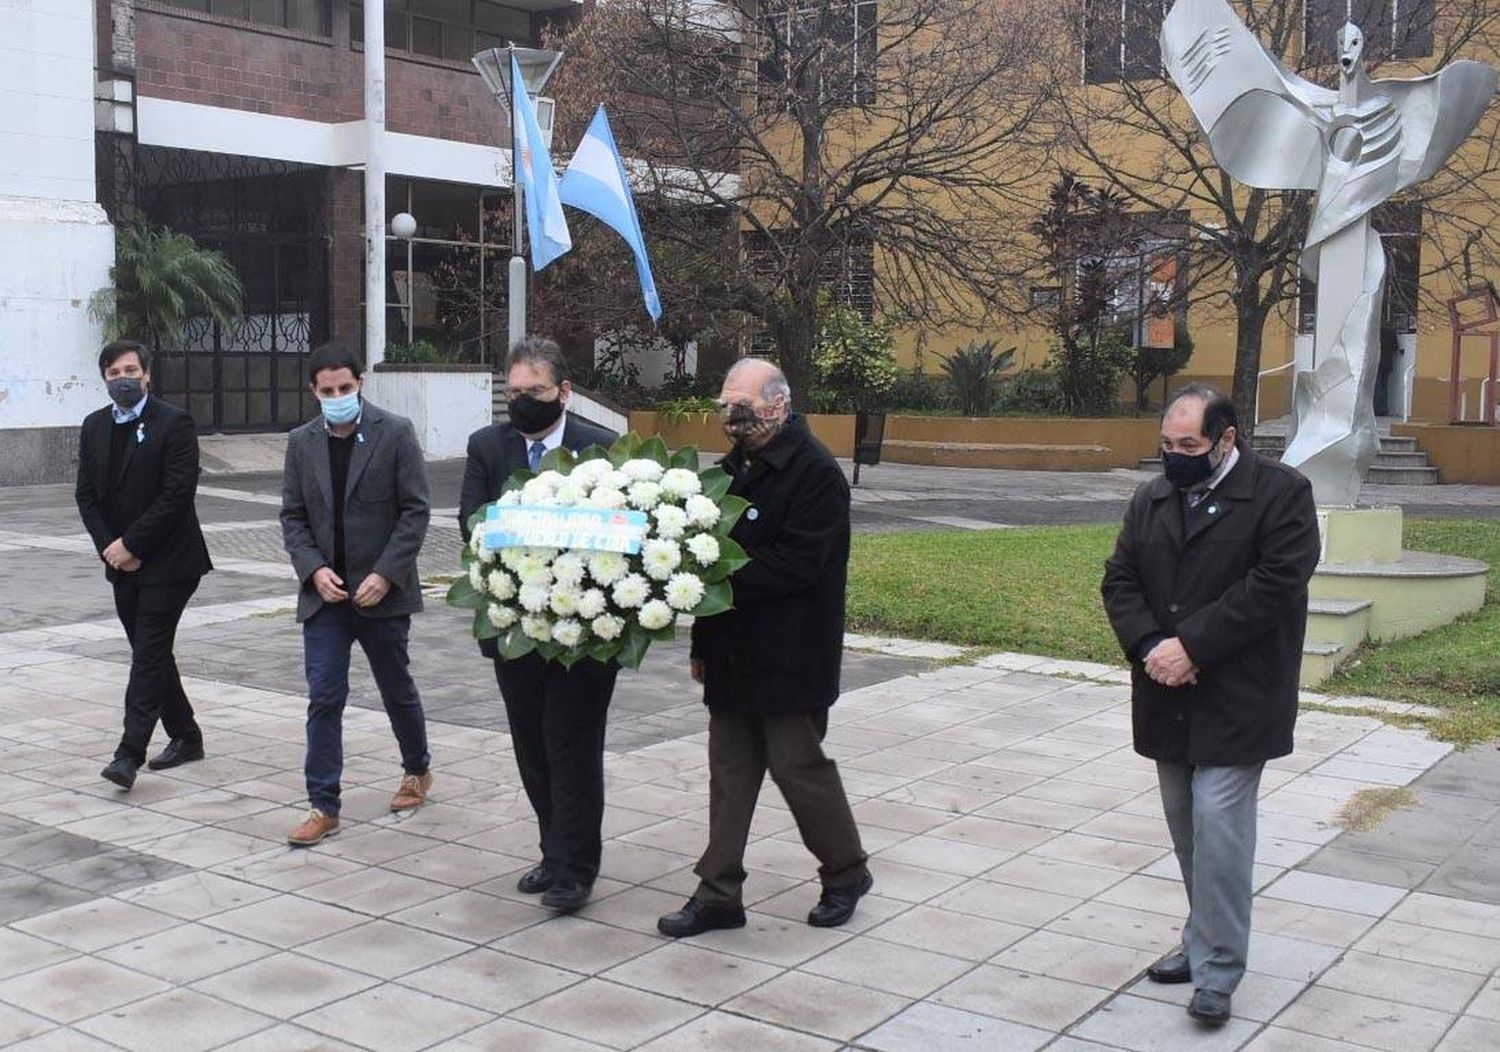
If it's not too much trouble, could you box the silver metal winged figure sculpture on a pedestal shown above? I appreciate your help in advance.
[1161,0,1496,504]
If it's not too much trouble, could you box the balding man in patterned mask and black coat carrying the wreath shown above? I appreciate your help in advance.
[657,359,872,936]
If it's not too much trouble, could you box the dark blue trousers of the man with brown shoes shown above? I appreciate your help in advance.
[302,600,429,815]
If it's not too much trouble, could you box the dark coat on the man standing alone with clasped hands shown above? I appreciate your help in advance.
[1103,443,1322,765]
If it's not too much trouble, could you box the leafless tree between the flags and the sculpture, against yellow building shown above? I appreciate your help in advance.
[557,0,1067,405]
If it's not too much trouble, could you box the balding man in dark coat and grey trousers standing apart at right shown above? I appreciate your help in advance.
[1103,384,1320,1025]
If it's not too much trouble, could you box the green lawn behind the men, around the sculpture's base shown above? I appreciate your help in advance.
[849,521,1500,741]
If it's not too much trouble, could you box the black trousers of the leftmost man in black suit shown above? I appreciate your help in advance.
[114,573,203,764]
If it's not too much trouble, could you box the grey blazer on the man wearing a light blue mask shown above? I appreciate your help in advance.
[281,401,431,621]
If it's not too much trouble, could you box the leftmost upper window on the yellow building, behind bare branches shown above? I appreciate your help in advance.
[759,0,878,107]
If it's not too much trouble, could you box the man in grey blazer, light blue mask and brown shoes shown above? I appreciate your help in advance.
[281,344,432,846]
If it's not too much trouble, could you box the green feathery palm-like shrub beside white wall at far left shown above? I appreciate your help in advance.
[92,227,245,351]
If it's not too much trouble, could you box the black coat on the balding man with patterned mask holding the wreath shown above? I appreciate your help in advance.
[693,416,849,714]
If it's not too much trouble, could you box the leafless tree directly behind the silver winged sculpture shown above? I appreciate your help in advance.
[1052,0,1500,429]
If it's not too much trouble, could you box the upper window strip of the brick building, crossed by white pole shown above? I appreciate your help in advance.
[350,0,536,62]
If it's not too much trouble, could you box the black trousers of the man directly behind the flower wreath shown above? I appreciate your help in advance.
[495,654,620,885]
